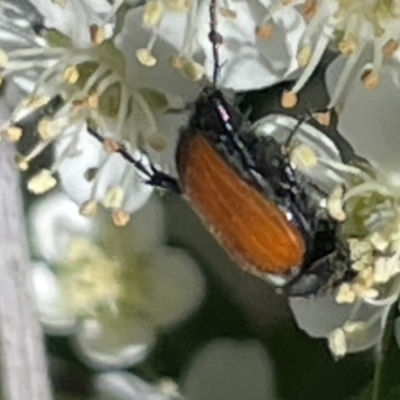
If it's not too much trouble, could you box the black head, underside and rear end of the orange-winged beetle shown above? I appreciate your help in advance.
[177,88,351,296]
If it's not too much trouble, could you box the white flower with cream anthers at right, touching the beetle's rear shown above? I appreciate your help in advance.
[254,115,400,357]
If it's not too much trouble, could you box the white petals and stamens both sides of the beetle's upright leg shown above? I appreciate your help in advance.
[143,0,305,91]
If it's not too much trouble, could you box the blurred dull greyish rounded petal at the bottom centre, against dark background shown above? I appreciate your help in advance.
[181,339,275,400]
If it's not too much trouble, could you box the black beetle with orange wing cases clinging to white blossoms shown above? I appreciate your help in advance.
[89,0,350,296]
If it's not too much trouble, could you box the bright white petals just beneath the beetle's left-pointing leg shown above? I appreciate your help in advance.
[56,126,152,220]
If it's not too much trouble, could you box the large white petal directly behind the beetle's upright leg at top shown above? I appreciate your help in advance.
[197,1,305,91]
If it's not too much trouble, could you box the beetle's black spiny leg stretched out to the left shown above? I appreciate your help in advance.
[87,124,181,194]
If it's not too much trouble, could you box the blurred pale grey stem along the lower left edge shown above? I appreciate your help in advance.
[0,143,51,400]
